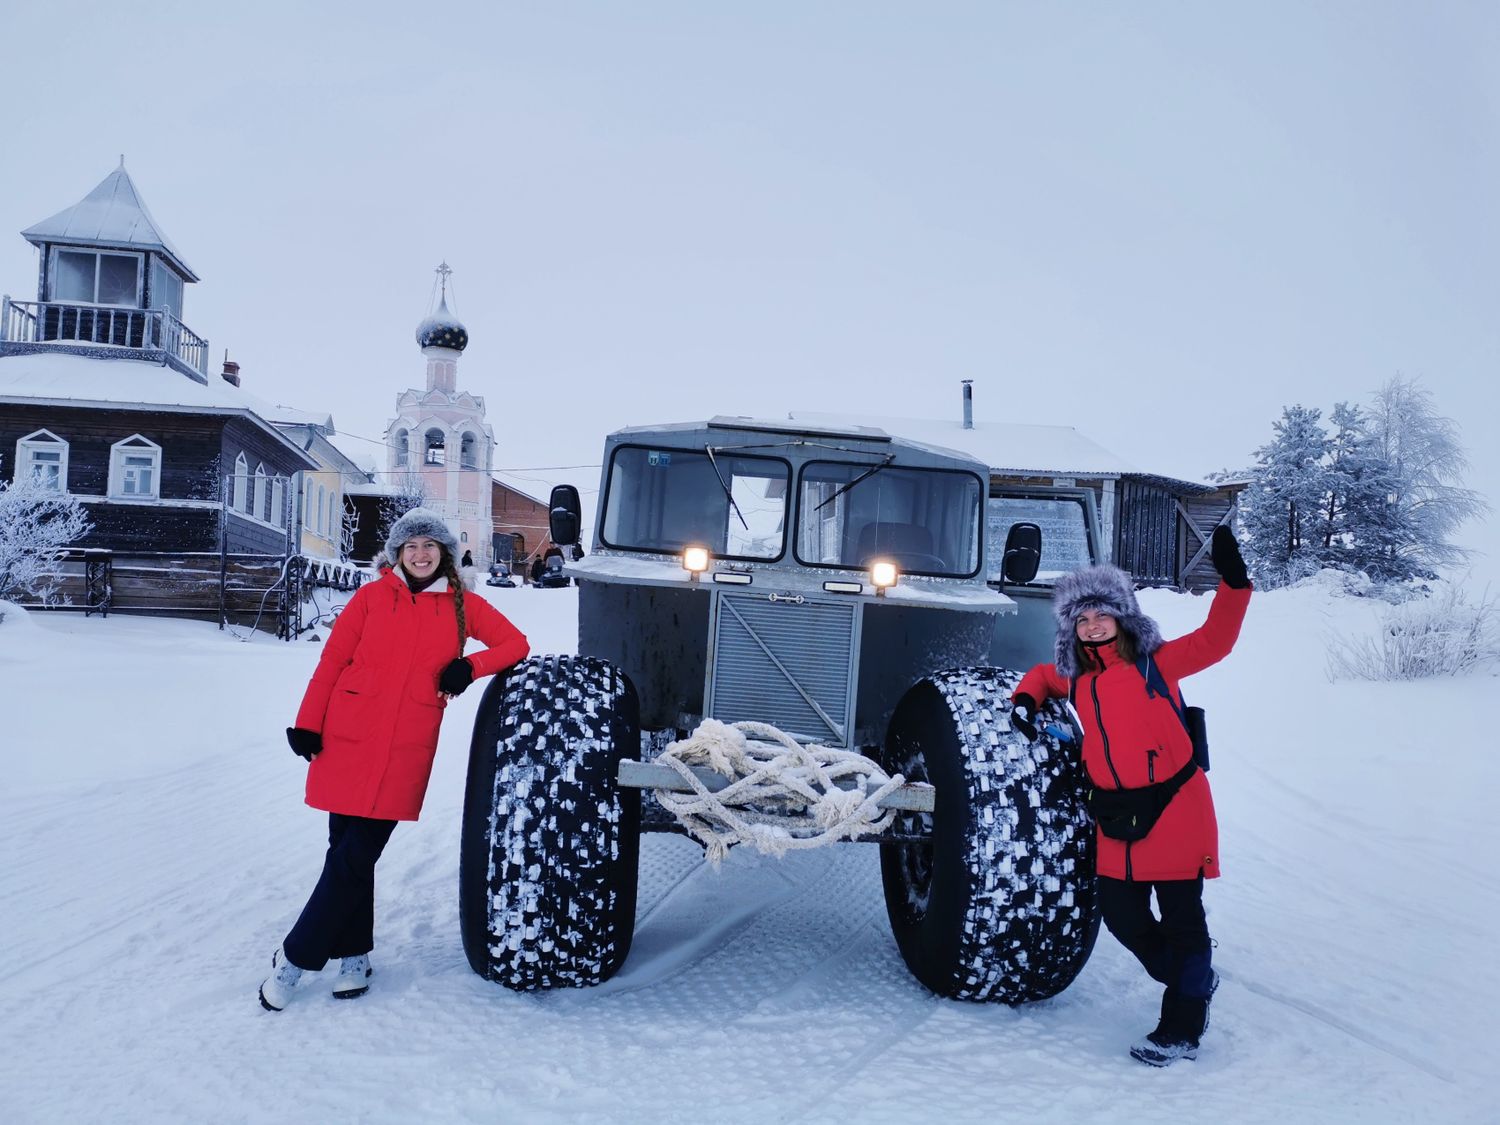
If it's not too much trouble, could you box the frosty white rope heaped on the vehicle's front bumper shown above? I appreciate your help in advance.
[656,719,905,866]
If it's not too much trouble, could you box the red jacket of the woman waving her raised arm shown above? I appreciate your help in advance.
[1016,582,1251,882]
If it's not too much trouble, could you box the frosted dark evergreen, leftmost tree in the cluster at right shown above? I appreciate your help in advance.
[1239,405,1329,587]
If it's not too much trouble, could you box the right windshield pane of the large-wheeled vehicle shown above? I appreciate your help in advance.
[797,461,981,578]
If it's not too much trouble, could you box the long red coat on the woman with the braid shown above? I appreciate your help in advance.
[297,570,531,821]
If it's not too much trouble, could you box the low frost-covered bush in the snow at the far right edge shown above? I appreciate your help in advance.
[1328,584,1500,681]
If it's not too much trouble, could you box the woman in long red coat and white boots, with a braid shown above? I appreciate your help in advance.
[261,509,530,1011]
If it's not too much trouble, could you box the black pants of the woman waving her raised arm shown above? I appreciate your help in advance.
[1100,875,1214,999]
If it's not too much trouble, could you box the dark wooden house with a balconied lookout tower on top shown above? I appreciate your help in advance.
[0,162,348,630]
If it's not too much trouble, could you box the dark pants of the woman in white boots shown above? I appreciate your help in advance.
[282,813,396,972]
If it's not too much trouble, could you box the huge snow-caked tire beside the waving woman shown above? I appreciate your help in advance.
[881,668,1100,1004]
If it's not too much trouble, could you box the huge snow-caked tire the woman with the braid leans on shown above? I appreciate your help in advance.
[459,656,641,992]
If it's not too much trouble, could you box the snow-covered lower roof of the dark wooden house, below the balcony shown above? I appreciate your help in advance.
[0,351,318,468]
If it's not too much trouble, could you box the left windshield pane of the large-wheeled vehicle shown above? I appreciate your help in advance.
[600,446,792,560]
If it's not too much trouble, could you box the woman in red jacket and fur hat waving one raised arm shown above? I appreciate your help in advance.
[1011,527,1251,1067]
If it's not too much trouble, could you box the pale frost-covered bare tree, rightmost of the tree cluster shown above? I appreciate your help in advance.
[1365,377,1490,581]
